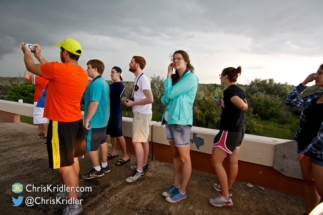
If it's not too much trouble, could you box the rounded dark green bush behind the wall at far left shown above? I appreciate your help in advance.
[7,82,34,104]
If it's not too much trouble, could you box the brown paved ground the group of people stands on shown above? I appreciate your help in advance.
[0,122,304,215]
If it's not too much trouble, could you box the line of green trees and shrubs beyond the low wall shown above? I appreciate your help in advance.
[0,76,319,138]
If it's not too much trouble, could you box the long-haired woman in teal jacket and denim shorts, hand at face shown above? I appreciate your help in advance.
[161,50,198,203]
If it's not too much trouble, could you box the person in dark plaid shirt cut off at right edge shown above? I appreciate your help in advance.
[285,64,323,214]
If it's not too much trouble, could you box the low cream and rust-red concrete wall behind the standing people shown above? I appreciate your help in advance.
[0,100,304,196]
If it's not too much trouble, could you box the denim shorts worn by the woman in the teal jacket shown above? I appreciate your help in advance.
[166,124,191,147]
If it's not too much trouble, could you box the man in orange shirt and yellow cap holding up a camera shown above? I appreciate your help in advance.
[21,38,88,214]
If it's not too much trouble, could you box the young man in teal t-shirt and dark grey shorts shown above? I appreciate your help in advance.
[82,59,110,179]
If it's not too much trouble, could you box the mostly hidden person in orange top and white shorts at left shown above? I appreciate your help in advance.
[24,70,48,139]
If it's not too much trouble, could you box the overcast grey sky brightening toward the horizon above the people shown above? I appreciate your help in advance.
[0,0,323,84]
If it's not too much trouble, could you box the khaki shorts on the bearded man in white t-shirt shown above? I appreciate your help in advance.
[132,113,152,143]
